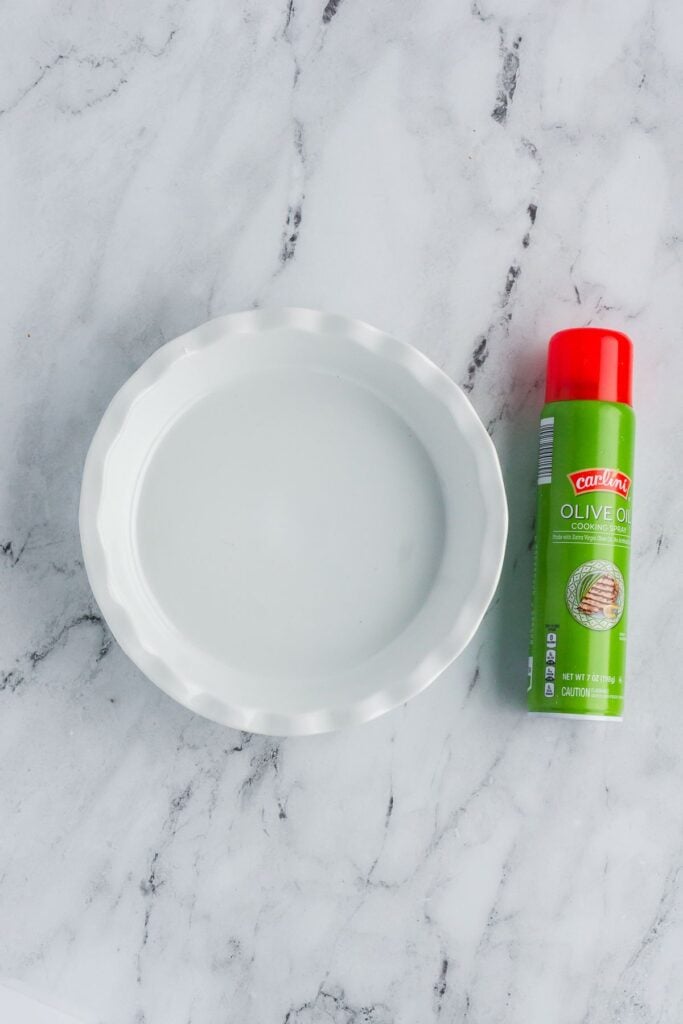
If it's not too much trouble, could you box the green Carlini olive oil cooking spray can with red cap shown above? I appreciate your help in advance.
[527,328,635,721]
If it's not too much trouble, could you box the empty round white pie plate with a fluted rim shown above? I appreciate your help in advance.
[80,309,507,735]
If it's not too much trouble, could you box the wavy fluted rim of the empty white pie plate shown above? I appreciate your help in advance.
[79,307,508,735]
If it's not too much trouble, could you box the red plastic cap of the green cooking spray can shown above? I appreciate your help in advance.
[546,327,633,406]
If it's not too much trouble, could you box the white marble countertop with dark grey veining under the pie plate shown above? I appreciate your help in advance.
[0,0,683,1024]
